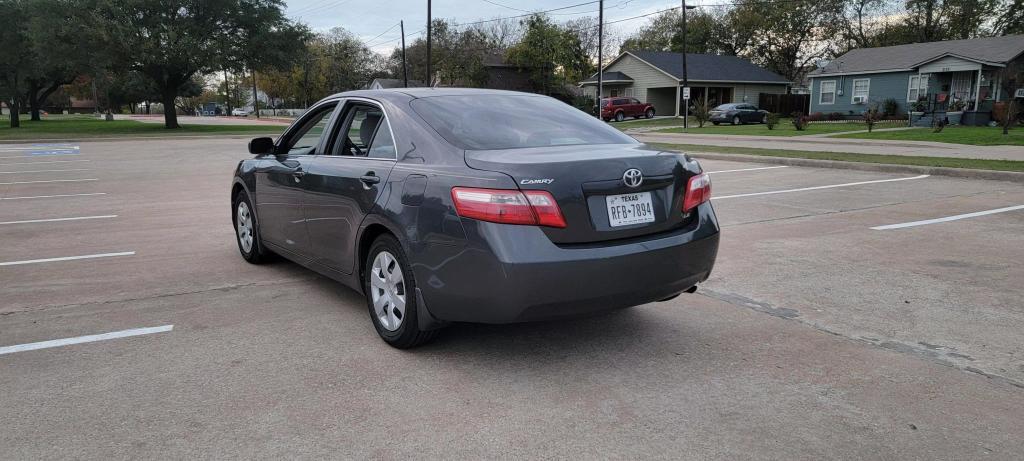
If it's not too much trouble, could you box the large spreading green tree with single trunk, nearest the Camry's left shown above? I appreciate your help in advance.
[98,0,301,128]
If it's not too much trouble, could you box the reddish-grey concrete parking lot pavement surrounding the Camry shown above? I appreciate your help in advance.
[0,139,1024,459]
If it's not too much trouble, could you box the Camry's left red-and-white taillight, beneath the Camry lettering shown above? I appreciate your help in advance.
[452,187,565,227]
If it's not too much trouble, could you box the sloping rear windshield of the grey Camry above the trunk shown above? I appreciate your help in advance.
[412,94,637,151]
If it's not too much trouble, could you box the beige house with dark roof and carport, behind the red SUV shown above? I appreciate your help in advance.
[580,51,792,116]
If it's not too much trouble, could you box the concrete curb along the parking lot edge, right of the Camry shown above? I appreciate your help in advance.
[687,152,1024,183]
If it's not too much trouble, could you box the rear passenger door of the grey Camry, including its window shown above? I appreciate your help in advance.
[304,100,397,274]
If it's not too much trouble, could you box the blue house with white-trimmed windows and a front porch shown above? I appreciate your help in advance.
[809,35,1024,126]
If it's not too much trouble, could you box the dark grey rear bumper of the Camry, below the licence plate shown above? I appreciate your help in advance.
[415,204,719,324]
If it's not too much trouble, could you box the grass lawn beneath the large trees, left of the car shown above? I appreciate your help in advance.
[0,117,285,140]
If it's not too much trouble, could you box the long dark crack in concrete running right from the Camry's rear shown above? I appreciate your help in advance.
[697,287,1024,389]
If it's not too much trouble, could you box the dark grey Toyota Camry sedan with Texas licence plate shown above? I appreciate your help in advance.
[230,88,719,347]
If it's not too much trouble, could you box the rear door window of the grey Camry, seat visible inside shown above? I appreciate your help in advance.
[331,104,395,159]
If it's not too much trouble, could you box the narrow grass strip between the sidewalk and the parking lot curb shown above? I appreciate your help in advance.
[650,142,1024,172]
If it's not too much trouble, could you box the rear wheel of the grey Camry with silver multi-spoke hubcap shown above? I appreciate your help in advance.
[362,235,438,349]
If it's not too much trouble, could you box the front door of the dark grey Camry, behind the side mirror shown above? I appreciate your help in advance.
[255,101,337,256]
